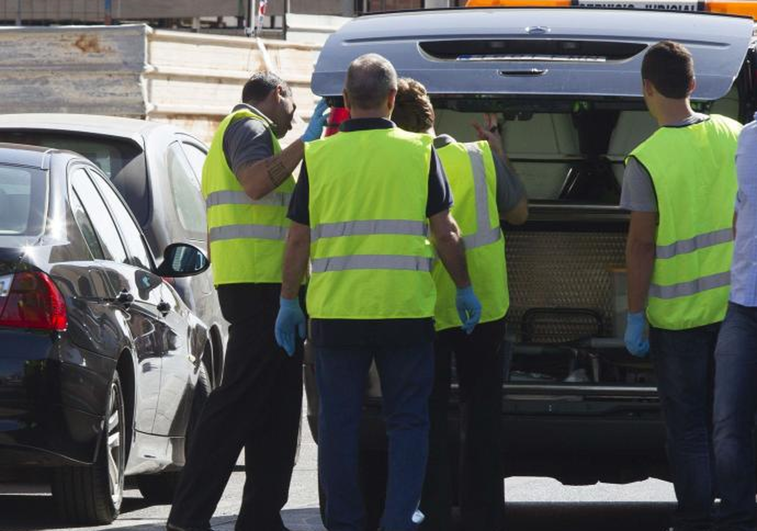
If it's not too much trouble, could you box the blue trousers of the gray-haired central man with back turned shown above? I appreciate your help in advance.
[315,343,434,531]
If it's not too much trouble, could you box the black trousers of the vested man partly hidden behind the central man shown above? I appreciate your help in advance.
[421,319,505,531]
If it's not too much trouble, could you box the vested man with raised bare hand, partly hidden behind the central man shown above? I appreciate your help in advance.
[392,78,528,531]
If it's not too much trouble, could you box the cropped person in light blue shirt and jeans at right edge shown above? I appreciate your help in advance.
[713,114,757,531]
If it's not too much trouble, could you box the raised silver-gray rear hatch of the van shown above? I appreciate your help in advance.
[312,8,755,101]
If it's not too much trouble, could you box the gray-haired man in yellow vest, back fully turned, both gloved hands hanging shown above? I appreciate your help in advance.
[276,54,481,531]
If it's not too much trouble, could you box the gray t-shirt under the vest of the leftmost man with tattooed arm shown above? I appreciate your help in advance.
[223,103,273,175]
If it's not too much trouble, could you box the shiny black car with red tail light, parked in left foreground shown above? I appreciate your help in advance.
[0,144,210,524]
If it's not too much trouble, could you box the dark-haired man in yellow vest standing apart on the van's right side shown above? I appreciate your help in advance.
[621,41,741,531]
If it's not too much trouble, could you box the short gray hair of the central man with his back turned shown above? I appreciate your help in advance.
[344,53,397,109]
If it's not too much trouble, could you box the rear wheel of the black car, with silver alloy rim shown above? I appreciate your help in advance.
[52,373,126,525]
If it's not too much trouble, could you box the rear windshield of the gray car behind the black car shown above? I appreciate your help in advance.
[0,133,150,226]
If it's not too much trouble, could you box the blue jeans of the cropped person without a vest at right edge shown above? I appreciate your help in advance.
[714,303,757,531]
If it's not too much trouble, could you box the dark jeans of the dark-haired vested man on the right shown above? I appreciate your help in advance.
[649,323,720,531]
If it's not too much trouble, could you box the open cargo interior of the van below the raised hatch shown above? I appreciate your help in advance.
[434,83,745,394]
